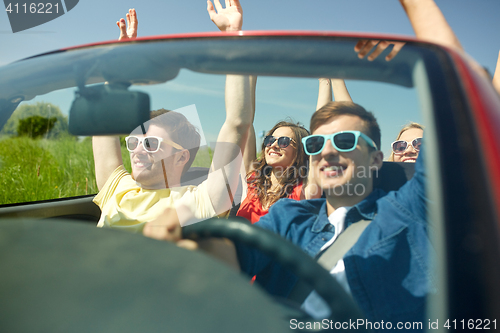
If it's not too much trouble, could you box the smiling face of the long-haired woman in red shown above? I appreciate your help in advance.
[264,127,297,168]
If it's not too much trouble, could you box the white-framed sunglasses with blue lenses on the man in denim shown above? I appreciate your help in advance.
[302,131,377,155]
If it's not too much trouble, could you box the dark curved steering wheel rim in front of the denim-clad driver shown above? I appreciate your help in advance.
[182,218,364,322]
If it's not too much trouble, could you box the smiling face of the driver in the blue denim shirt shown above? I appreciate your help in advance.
[311,115,383,207]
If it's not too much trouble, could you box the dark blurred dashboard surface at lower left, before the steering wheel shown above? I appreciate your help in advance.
[0,219,320,333]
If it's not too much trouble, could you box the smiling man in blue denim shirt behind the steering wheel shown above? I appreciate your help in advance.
[236,102,431,327]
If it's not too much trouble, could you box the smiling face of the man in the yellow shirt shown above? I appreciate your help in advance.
[130,125,182,189]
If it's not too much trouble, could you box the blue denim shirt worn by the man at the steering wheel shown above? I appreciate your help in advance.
[237,149,433,327]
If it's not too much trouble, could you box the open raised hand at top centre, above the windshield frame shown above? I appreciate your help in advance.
[207,0,243,31]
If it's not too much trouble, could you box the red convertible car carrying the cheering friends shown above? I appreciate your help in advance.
[0,32,500,332]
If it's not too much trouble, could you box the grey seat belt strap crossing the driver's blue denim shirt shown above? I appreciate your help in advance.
[288,220,371,304]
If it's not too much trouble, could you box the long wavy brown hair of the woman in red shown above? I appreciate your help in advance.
[247,121,309,207]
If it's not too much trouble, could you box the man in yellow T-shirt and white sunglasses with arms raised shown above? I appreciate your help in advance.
[92,9,252,232]
